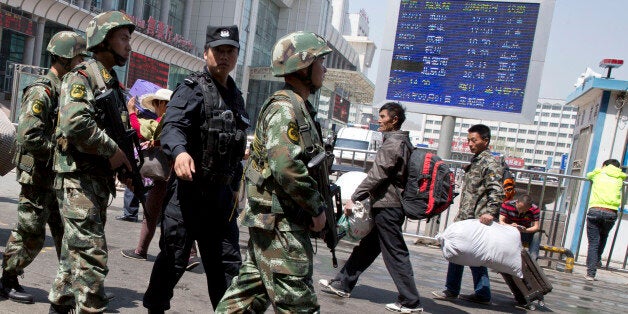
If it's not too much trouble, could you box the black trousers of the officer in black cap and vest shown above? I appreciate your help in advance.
[143,179,242,310]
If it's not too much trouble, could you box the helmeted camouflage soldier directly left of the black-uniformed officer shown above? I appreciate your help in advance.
[48,11,135,313]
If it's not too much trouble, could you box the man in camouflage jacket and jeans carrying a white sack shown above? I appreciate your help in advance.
[432,124,504,304]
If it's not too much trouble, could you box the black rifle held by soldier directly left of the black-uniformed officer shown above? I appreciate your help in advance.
[94,89,146,209]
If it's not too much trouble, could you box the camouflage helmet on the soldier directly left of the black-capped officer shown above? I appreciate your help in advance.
[85,11,135,51]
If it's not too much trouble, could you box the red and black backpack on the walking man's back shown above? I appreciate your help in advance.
[401,148,457,221]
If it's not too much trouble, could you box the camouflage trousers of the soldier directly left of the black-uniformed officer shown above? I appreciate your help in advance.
[48,182,109,313]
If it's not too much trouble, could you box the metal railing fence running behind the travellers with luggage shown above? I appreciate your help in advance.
[332,149,628,270]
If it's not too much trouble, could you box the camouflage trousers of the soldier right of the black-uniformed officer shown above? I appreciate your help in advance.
[216,228,320,313]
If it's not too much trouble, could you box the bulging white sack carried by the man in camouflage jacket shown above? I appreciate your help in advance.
[436,219,523,278]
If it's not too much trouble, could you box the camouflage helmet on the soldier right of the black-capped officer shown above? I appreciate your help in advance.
[271,32,331,76]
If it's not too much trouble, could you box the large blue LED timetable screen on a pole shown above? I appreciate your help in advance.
[386,0,539,113]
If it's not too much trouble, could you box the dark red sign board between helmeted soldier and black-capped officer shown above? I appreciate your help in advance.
[126,52,170,88]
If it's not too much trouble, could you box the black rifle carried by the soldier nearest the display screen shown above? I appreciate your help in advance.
[307,145,342,268]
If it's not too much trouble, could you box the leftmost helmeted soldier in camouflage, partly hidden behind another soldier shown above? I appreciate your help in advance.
[0,31,87,303]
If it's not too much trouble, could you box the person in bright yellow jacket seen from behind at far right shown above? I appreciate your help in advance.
[585,159,626,281]
